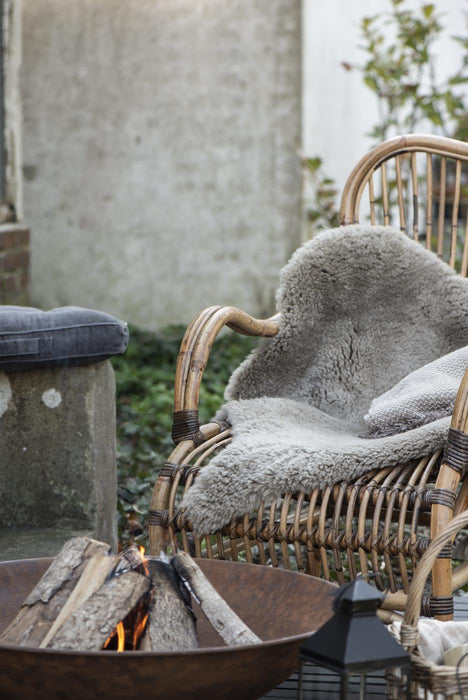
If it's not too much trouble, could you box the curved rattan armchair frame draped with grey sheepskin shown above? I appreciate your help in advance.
[148,135,468,619]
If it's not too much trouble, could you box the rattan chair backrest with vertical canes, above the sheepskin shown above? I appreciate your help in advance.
[340,134,468,277]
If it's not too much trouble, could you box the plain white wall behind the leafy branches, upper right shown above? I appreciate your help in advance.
[302,0,468,221]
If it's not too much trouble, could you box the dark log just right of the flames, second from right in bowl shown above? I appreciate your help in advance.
[140,559,199,651]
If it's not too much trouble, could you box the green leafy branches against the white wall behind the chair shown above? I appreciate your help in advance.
[302,0,468,237]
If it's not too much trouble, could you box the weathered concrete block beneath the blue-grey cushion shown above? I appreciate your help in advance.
[0,361,117,560]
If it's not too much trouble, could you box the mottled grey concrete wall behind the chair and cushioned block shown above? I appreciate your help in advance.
[22,0,301,327]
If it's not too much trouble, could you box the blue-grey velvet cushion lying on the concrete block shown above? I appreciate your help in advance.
[0,306,128,371]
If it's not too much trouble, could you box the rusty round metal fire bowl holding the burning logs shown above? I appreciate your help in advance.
[0,559,333,700]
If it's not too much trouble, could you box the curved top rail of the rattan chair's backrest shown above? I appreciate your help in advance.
[339,134,468,225]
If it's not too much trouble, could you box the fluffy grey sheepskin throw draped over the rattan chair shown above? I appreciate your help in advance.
[182,225,468,534]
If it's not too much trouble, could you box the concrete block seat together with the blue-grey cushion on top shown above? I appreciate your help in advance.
[0,306,128,560]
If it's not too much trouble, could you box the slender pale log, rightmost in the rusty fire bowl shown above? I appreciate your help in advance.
[171,552,262,645]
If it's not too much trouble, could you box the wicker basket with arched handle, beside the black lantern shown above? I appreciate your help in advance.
[387,510,468,699]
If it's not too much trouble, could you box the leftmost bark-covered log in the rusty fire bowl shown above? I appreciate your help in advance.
[0,537,111,647]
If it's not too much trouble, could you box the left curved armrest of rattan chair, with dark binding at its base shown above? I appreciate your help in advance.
[172,306,279,443]
